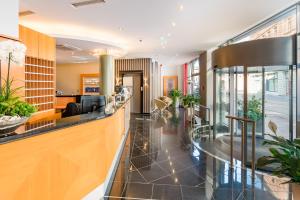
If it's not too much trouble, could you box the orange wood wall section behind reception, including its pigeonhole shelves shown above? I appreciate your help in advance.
[19,26,56,112]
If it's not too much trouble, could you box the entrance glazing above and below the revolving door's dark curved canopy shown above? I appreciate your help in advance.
[214,4,300,139]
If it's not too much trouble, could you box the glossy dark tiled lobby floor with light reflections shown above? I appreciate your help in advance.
[105,110,293,200]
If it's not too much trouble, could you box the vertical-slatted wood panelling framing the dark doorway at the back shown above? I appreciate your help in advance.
[115,58,152,113]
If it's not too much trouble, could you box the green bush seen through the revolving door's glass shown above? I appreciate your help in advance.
[246,96,263,121]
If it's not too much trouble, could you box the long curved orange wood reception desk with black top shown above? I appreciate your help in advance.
[0,100,130,200]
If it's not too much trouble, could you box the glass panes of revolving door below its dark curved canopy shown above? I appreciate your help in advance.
[215,66,296,138]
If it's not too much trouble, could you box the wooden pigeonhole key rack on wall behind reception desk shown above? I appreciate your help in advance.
[25,56,55,111]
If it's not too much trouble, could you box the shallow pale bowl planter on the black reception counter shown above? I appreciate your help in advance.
[0,116,28,135]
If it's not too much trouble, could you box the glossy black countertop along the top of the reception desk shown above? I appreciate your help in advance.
[0,102,126,145]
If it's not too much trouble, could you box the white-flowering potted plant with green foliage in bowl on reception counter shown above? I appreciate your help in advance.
[0,40,37,134]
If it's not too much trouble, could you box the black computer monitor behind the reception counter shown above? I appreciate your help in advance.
[80,96,106,114]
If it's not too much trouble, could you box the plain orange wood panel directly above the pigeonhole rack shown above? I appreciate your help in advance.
[19,25,56,61]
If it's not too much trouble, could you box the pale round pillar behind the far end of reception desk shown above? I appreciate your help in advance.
[100,55,115,97]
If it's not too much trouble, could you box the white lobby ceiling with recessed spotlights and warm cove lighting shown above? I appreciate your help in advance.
[20,0,297,66]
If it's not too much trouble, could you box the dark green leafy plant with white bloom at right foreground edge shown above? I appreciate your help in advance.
[257,121,300,183]
